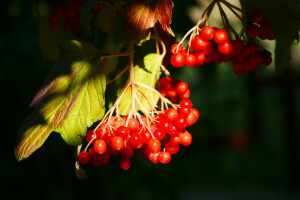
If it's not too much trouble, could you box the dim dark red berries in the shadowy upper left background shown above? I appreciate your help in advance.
[49,0,83,37]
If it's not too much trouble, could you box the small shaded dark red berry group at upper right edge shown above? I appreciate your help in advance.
[247,10,277,40]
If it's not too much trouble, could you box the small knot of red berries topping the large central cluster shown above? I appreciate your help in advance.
[159,77,191,102]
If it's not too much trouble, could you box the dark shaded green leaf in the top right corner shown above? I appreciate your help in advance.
[241,0,300,74]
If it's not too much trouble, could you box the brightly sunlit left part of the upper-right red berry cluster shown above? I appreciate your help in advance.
[171,26,232,68]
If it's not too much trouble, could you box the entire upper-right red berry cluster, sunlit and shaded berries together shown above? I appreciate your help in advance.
[170,5,277,75]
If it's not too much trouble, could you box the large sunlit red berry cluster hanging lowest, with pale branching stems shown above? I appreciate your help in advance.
[78,77,199,170]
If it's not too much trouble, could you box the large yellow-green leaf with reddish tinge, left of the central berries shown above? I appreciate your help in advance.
[15,41,106,160]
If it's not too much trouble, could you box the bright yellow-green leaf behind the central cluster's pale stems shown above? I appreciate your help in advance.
[119,53,163,115]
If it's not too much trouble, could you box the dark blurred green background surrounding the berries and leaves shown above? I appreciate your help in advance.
[0,0,300,200]
